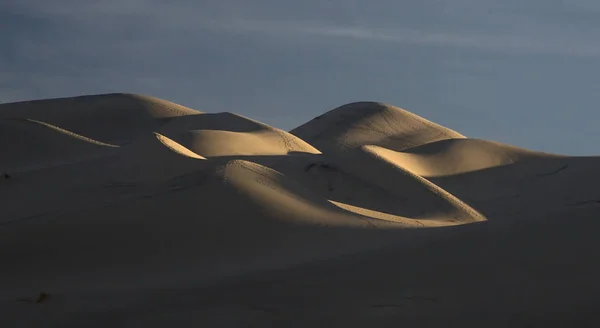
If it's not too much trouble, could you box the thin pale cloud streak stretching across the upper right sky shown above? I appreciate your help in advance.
[202,19,600,56]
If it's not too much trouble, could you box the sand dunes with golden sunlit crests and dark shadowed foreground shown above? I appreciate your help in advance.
[0,94,600,327]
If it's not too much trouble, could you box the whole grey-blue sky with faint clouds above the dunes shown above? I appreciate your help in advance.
[0,0,600,155]
